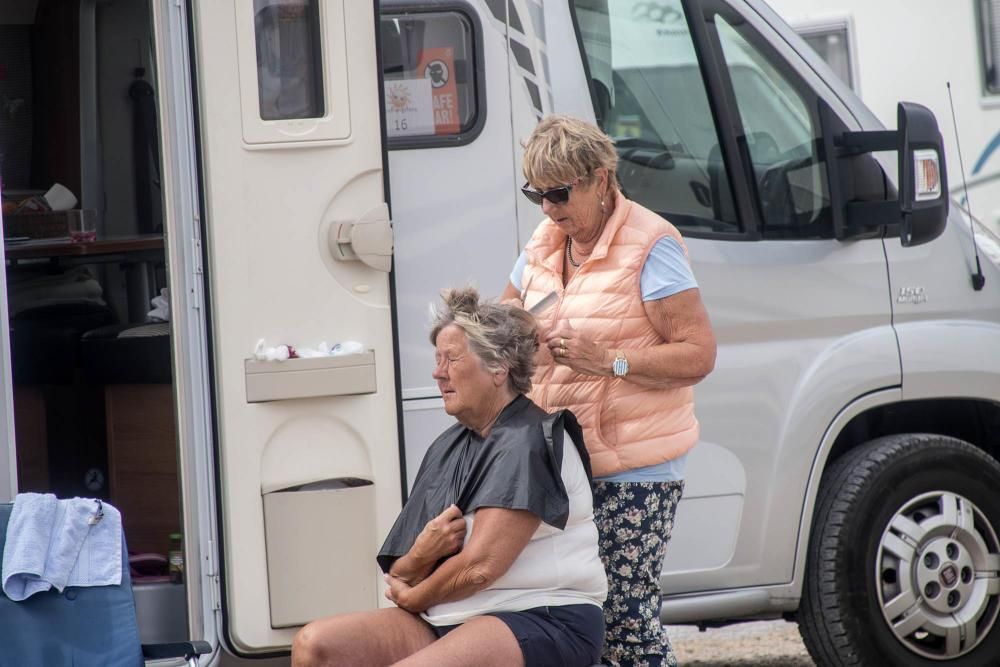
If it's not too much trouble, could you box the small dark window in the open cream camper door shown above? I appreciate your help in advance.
[253,0,324,120]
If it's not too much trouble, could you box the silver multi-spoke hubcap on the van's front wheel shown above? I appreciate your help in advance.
[875,491,1000,660]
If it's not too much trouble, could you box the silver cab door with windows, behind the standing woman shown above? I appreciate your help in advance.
[572,0,900,596]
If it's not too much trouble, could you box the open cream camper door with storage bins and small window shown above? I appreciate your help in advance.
[192,0,401,655]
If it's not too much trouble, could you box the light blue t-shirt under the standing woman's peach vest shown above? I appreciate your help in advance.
[510,236,698,482]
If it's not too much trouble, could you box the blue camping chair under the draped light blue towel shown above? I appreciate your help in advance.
[0,503,212,667]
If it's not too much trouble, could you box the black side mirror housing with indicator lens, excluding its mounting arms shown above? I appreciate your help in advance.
[896,102,948,246]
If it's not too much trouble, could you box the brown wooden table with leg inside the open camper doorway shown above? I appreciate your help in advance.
[4,234,163,322]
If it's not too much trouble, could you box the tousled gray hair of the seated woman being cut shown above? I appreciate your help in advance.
[430,287,538,394]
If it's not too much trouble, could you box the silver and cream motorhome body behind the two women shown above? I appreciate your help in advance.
[0,0,1000,664]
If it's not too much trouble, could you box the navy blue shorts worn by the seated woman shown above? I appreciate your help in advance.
[431,604,604,667]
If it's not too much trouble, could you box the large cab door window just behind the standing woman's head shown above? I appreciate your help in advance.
[573,0,740,233]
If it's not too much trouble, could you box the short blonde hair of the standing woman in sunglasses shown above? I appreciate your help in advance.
[521,115,618,188]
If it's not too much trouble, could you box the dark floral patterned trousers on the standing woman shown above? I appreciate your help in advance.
[594,481,684,667]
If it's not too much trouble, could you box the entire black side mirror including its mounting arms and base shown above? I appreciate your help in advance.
[820,102,948,246]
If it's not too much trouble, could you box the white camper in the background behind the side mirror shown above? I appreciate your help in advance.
[770,0,1000,231]
